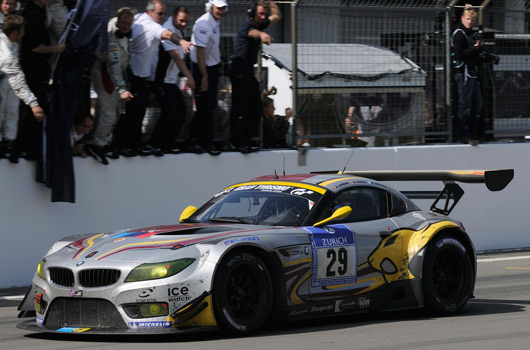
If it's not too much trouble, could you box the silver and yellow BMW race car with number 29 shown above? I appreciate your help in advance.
[18,170,514,334]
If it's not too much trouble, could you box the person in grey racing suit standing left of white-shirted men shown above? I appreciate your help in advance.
[86,7,134,165]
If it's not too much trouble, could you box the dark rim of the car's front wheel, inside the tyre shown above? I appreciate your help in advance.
[226,266,262,320]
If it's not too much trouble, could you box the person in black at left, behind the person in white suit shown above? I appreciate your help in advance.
[17,0,66,159]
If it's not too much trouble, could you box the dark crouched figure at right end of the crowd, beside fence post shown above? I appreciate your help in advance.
[263,97,289,148]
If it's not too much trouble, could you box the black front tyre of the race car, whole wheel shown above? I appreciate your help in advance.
[213,253,272,334]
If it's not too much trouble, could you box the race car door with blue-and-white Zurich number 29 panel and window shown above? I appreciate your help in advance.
[310,186,396,301]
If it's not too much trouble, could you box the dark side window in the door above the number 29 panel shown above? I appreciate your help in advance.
[331,187,387,222]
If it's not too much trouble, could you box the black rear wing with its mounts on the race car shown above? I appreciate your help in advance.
[315,169,514,215]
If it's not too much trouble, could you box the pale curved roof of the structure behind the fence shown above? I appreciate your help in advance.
[263,44,426,89]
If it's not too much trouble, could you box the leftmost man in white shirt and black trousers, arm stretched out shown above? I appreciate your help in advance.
[114,0,191,157]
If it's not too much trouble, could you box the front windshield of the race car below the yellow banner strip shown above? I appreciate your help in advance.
[187,185,322,226]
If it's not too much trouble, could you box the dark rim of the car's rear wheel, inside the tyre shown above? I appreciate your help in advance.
[432,248,465,301]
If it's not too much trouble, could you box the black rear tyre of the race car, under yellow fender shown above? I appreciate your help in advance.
[423,236,474,315]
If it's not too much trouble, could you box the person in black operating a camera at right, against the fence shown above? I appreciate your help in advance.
[451,6,483,145]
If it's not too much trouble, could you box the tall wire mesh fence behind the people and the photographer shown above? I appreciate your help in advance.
[111,0,530,147]
